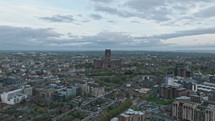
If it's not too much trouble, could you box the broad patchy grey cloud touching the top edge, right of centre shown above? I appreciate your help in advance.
[124,0,186,22]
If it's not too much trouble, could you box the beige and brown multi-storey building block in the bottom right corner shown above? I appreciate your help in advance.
[172,95,215,121]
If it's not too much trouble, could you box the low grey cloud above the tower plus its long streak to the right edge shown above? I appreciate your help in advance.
[40,27,215,49]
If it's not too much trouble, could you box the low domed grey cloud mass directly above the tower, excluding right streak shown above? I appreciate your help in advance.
[54,32,164,49]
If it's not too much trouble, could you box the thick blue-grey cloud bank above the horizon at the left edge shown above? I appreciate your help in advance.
[0,26,62,50]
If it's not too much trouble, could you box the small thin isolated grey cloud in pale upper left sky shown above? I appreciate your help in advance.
[40,15,75,23]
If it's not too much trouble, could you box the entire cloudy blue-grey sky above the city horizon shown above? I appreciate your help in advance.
[0,0,215,51]
